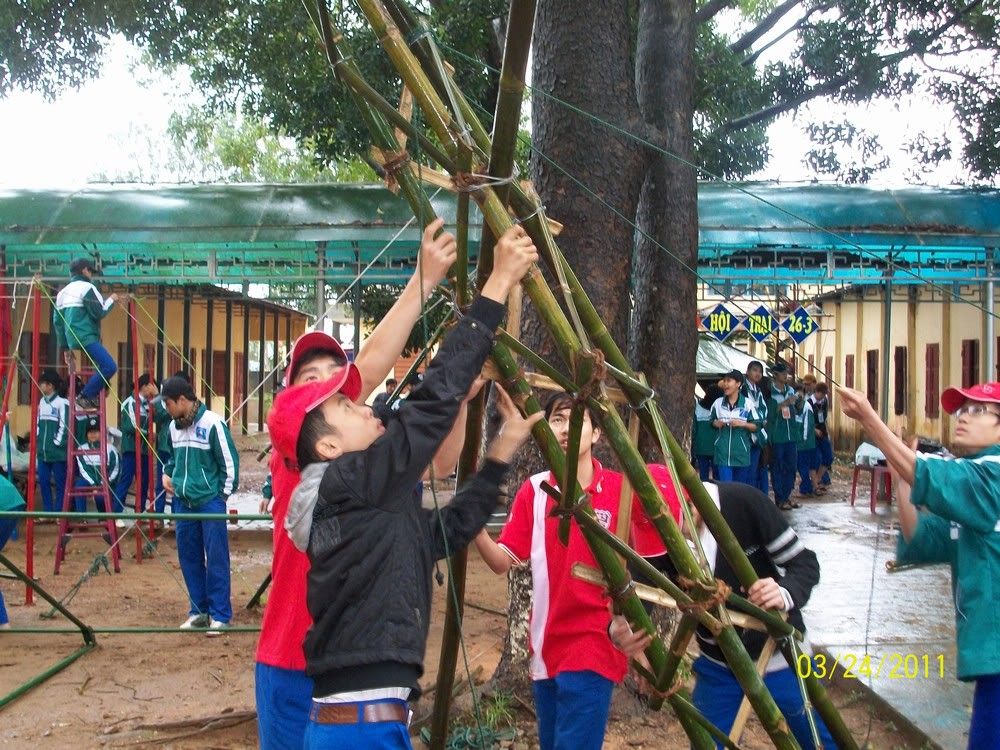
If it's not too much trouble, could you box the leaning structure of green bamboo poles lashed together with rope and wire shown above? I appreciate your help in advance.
[303,0,857,750]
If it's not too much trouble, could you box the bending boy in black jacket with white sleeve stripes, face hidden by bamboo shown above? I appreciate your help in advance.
[660,482,836,748]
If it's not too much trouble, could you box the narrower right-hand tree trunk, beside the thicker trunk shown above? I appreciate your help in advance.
[629,0,698,458]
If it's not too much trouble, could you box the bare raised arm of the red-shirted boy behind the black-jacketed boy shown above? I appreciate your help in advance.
[355,219,458,401]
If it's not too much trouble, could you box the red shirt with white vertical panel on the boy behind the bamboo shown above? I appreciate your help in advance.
[498,461,680,682]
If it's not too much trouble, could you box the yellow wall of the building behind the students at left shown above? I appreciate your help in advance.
[10,287,306,435]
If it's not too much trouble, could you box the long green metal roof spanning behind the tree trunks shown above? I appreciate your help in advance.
[0,183,1000,284]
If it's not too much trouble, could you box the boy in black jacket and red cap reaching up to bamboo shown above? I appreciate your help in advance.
[269,227,540,748]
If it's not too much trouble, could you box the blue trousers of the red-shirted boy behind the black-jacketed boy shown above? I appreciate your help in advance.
[254,662,313,750]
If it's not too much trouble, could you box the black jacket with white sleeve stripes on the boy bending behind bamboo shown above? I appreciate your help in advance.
[664,482,819,662]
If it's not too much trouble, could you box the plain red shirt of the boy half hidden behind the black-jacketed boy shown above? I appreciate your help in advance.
[257,452,312,672]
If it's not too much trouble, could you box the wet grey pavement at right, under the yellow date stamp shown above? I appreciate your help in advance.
[789,494,972,750]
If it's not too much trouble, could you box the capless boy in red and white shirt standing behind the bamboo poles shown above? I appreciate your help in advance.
[476,392,681,750]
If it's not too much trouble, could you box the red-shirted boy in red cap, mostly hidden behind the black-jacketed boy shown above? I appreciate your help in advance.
[254,219,480,750]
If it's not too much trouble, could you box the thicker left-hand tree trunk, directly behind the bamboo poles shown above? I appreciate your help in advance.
[496,0,641,688]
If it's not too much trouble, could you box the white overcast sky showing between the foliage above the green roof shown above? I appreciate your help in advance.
[0,35,964,188]
